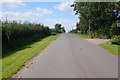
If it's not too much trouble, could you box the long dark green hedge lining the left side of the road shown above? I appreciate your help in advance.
[2,21,50,56]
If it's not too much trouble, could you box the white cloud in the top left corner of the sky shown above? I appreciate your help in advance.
[0,0,25,8]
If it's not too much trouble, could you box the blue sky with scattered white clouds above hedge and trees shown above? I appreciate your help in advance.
[0,0,79,32]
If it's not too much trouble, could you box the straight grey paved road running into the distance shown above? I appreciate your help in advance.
[22,34,118,78]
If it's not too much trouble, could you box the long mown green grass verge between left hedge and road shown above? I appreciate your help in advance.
[0,34,60,78]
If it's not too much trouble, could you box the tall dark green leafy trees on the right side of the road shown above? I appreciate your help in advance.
[71,2,120,38]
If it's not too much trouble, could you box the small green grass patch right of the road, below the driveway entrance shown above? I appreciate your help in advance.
[98,42,120,56]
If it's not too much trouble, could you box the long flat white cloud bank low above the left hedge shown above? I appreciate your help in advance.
[0,11,43,21]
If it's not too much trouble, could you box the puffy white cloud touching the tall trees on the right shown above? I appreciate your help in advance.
[54,2,73,11]
